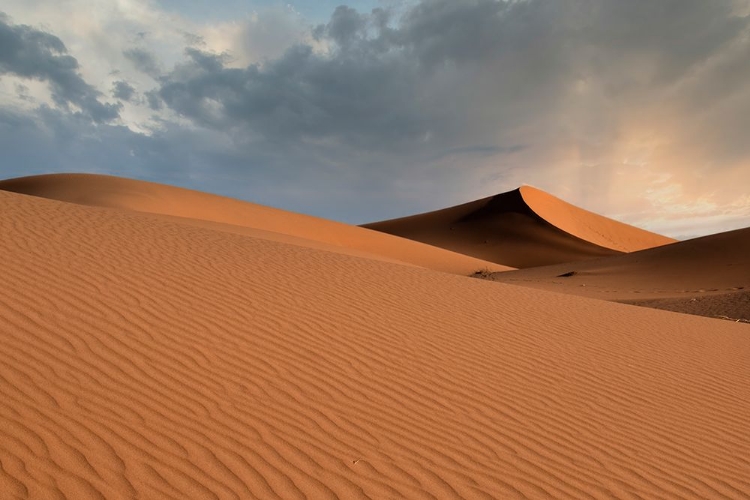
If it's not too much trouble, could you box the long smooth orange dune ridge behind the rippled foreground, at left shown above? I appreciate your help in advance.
[0,174,510,275]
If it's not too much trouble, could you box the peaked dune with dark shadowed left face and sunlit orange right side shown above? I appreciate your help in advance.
[363,186,674,268]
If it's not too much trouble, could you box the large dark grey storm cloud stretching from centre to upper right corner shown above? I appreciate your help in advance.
[153,0,748,160]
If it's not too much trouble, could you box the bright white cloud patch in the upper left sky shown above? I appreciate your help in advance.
[0,0,305,132]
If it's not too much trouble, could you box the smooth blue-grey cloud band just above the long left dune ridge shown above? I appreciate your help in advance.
[0,106,416,221]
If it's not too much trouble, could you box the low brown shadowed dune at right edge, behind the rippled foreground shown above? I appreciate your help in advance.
[491,228,750,320]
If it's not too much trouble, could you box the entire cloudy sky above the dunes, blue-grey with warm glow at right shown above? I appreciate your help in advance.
[0,0,750,239]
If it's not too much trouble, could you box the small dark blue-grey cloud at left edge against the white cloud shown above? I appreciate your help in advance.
[0,15,119,123]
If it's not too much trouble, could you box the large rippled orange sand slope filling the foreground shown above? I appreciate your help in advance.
[0,191,750,499]
